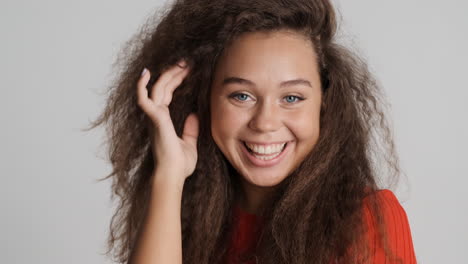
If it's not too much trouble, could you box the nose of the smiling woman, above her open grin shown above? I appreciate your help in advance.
[249,102,281,132]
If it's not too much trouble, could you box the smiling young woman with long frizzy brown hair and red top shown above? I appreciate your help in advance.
[93,0,416,264]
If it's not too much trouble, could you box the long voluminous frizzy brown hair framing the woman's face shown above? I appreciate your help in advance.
[90,0,400,264]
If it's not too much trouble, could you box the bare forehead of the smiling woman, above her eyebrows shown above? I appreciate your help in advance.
[215,31,318,86]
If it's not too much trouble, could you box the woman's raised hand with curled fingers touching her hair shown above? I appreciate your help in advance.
[137,61,199,184]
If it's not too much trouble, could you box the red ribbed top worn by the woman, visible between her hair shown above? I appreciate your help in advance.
[226,189,416,264]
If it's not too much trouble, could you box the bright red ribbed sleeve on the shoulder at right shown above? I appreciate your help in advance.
[364,189,416,264]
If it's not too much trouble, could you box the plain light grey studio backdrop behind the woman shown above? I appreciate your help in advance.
[0,0,468,264]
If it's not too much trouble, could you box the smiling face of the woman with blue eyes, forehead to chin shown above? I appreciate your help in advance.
[210,31,321,190]
